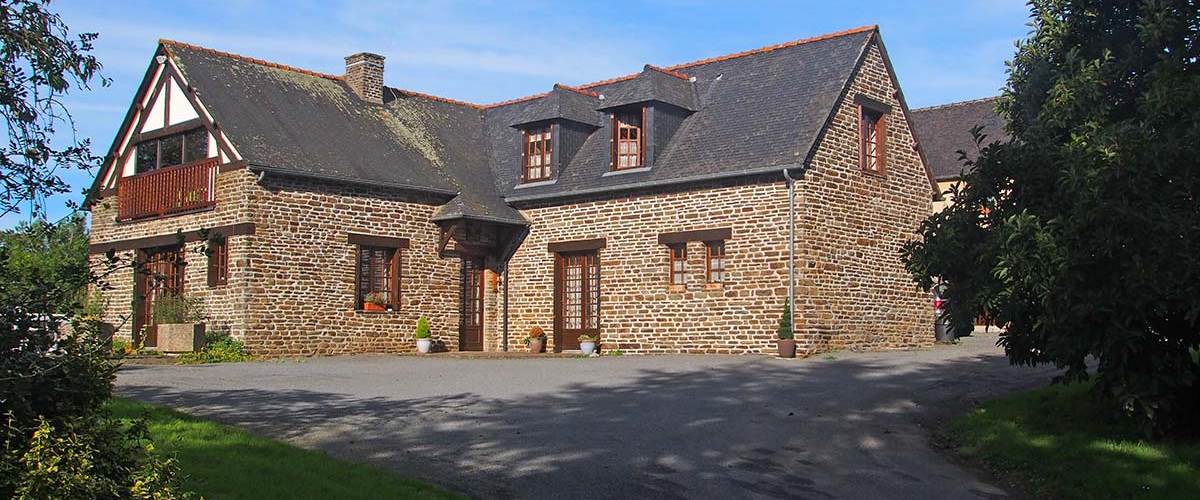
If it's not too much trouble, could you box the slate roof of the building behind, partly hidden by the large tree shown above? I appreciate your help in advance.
[910,97,1008,181]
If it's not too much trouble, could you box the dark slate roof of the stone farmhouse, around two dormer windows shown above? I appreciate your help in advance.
[142,26,902,223]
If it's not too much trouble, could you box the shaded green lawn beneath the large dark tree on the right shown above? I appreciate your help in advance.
[942,384,1200,499]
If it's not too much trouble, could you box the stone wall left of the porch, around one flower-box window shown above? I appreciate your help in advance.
[246,175,460,355]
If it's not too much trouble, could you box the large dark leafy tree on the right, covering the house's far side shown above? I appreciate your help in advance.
[902,0,1200,432]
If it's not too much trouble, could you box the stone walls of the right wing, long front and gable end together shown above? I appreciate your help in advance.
[490,38,934,354]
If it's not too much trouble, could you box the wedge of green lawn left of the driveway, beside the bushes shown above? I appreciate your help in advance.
[109,398,461,500]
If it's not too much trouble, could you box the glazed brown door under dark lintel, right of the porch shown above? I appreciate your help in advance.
[554,251,600,353]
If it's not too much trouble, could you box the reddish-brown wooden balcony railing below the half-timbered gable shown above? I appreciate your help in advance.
[116,158,217,221]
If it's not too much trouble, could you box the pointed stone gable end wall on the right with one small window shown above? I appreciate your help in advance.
[796,40,934,351]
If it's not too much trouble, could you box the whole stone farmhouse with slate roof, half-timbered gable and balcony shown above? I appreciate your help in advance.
[86,26,937,356]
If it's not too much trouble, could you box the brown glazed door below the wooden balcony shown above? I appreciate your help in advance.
[133,246,185,348]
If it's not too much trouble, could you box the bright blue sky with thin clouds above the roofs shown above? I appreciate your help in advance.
[0,0,1028,228]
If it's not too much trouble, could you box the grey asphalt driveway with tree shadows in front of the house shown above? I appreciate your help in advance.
[116,335,1054,499]
